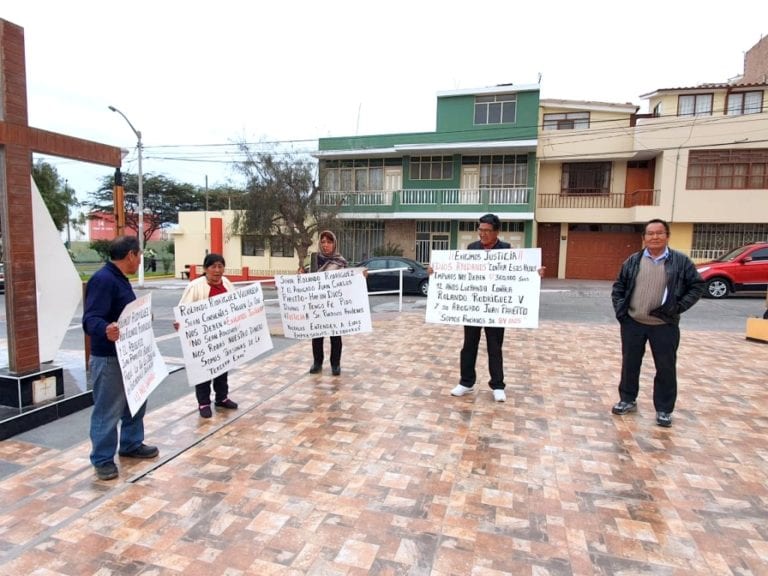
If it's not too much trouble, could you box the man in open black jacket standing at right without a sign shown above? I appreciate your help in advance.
[611,219,704,427]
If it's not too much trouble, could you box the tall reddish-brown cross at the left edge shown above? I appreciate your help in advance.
[0,19,121,374]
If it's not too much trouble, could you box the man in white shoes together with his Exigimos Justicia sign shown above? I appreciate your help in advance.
[426,214,543,402]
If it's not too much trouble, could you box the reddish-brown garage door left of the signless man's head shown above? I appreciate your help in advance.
[565,230,642,280]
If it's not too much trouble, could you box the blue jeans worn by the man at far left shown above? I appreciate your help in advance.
[91,356,147,466]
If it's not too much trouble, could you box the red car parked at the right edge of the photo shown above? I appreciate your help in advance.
[696,242,768,298]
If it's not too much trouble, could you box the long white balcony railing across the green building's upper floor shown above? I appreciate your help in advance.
[319,188,532,206]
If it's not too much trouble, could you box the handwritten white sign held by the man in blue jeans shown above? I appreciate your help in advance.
[115,294,168,416]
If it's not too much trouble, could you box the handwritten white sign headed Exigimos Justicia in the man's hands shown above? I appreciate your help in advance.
[426,248,541,328]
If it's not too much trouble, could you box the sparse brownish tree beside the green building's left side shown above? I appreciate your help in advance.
[232,143,338,266]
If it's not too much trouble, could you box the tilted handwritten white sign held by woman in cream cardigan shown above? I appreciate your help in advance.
[173,283,272,386]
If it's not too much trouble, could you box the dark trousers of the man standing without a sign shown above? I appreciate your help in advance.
[619,318,680,412]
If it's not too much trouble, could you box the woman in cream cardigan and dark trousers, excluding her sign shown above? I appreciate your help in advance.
[173,254,237,418]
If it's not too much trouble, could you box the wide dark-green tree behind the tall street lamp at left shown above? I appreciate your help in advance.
[90,174,205,244]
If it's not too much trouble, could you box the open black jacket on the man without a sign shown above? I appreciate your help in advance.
[611,249,705,324]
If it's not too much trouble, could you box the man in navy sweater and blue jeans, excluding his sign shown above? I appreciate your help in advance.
[83,236,159,480]
